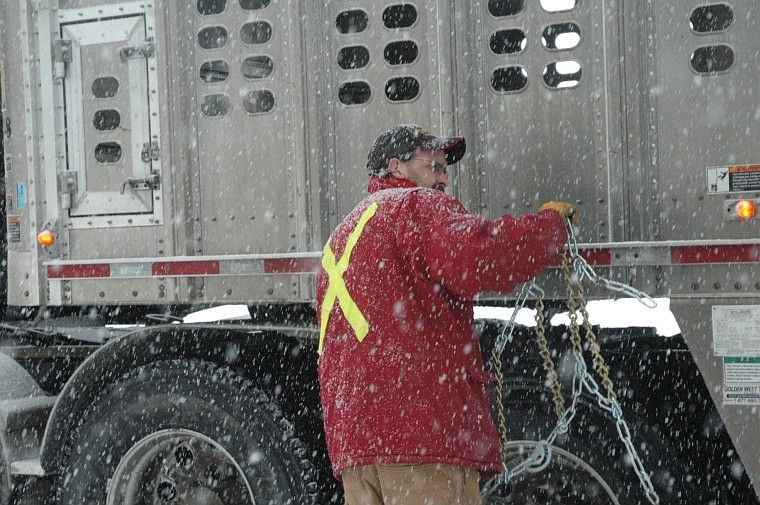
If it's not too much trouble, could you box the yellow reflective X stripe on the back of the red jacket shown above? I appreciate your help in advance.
[317,202,377,355]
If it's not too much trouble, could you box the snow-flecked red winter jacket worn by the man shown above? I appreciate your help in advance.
[317,177,566,479]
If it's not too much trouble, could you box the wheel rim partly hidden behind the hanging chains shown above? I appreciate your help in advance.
[484,440,620,505]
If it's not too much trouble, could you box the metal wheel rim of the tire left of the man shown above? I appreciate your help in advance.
[106,429,256,505]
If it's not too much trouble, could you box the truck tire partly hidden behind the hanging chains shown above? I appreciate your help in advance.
[483,384,682,505]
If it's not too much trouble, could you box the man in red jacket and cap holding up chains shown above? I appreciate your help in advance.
[317,125,571,505]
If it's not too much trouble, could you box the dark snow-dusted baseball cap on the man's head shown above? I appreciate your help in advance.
[367,124,467,176]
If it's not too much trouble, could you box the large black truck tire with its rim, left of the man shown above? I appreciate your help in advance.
[57,360,316,505]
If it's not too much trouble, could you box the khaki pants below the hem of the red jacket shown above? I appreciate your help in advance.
[341,464,481,505]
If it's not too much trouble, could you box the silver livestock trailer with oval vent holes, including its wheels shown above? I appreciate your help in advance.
[0,0,760,505]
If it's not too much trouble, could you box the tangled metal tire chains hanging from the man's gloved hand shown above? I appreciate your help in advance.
[481,223,660,505]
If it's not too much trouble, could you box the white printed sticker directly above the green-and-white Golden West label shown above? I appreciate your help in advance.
[712,305,760,358]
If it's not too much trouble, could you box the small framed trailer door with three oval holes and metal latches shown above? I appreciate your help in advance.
[55,9,161,223]
